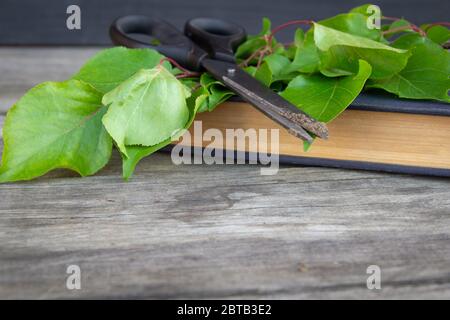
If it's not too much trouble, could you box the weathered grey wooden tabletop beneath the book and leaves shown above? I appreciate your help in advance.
[0,48,450,299]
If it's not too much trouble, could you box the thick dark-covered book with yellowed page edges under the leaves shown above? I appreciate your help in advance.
[172,93,450,177]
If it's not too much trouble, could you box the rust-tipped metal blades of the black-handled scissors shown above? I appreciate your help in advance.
[201,58,328,142]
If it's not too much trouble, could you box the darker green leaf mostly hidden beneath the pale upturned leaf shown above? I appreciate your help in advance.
[122,94,208,180]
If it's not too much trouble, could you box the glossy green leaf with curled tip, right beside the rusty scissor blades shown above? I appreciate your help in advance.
[281,60,372,122]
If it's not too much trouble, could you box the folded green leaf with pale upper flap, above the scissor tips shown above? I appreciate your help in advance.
[314,23,410,79]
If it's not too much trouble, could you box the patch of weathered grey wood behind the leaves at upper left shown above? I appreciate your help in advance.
[0,47,99,114]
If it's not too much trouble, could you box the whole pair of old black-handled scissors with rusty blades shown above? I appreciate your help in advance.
[110,15,328,142]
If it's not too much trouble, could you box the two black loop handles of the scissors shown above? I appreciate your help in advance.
[110,16,246,71]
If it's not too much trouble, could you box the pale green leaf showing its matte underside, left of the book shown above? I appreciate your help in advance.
[103,66,190,155]
